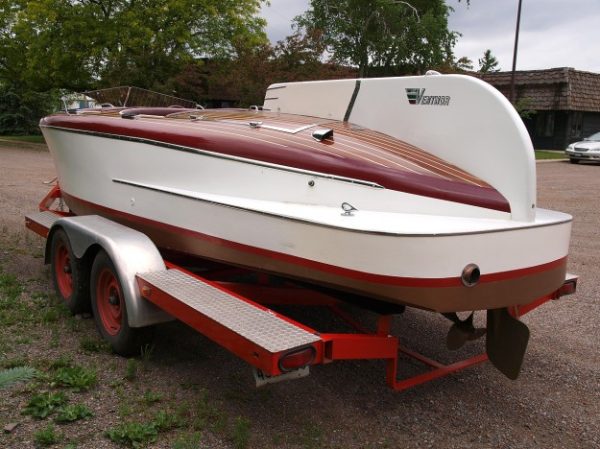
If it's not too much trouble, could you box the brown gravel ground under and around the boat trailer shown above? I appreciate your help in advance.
[0,146,600,449]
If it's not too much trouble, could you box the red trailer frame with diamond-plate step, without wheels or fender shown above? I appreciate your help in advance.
[26,185,577,391]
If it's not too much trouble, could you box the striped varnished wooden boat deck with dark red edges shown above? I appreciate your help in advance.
[43,108,510,212]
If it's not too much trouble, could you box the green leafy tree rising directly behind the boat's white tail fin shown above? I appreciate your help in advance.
[295,0,456,77]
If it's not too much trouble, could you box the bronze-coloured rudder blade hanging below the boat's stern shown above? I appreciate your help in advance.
[485,308,529,380]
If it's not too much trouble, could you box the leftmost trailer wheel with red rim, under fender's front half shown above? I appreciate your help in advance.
[50,229,90,314]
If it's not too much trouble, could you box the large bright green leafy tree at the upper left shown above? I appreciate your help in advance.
[0,0,266,91]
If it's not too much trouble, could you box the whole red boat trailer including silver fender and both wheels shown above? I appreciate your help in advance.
[26,186,577,391]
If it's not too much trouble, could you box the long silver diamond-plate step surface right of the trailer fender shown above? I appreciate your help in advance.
[137,269,320,353]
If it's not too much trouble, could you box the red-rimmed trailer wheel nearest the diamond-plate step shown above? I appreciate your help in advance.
[91,250,154,357]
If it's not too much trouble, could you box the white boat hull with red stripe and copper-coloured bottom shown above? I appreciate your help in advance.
[43,124,571,312]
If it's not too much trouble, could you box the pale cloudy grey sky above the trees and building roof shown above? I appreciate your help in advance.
[262,0,600,73]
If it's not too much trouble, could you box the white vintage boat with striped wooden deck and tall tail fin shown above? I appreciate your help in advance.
[40,75,571,312]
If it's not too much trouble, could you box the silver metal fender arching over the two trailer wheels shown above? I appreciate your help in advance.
[45,215,173,327]
